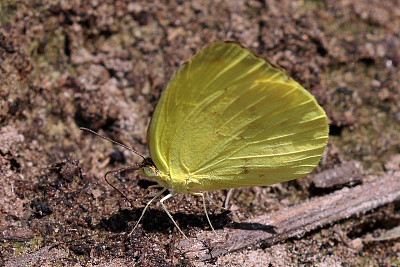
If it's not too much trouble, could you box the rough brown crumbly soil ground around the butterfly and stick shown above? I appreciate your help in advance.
[0,0,400,266]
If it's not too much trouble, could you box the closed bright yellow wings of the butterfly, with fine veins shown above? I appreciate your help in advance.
[148,42,328,192]
